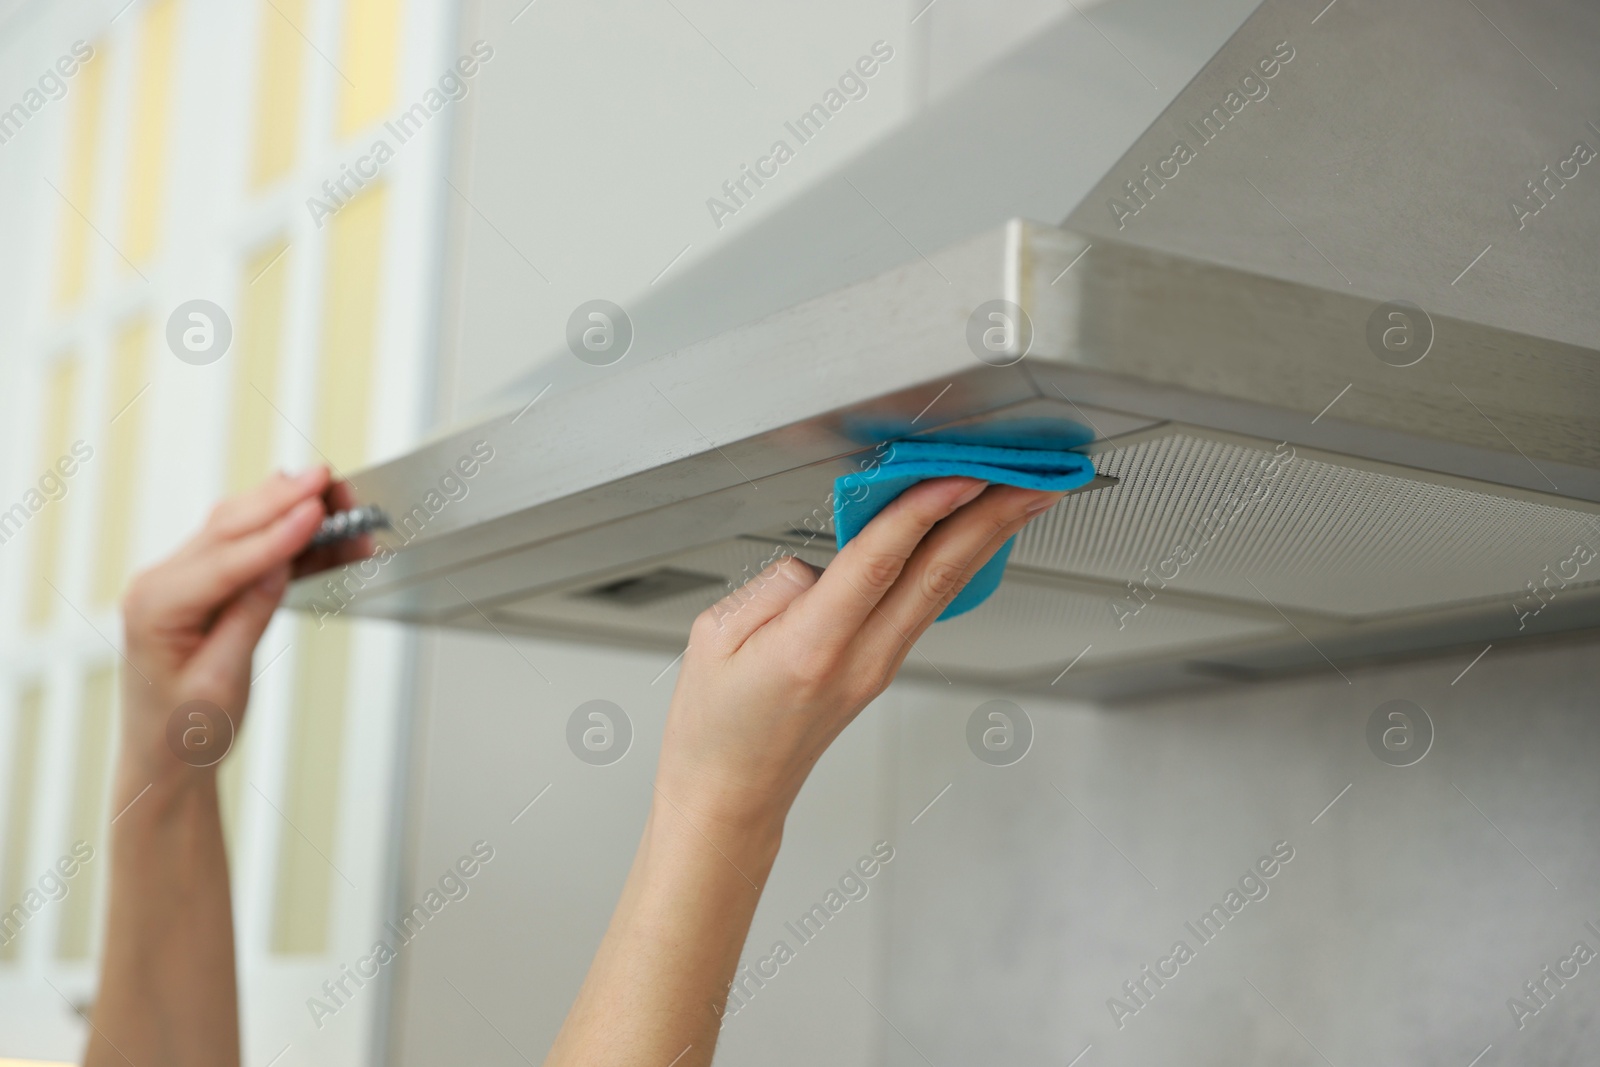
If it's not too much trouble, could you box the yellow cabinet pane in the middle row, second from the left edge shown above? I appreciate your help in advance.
[91,315,150,608]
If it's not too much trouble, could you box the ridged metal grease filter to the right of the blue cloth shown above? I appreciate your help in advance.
[1011,434,1600,616]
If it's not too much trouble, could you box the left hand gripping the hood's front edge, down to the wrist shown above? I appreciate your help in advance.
[122,467,371,789]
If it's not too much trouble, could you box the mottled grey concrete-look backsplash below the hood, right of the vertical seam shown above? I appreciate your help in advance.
[880,638,1600,1067]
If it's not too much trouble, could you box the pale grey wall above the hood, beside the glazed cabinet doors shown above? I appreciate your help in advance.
[440,0,917,418]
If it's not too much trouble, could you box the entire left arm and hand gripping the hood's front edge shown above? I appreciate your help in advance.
[83,467,371,1067]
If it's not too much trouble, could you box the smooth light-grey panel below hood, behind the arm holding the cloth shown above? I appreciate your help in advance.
[392,633,899,1067]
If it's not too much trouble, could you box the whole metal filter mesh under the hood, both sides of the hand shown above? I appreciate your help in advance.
[496,427,1600,683]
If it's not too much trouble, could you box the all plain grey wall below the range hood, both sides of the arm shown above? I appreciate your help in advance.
[395,635,1600,1067]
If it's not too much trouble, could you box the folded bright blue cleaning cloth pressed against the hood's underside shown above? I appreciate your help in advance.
[834,437,1094,622]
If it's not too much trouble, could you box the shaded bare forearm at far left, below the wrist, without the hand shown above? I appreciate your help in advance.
[83,758,238,1067]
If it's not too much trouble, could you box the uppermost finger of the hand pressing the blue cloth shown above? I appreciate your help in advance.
[790,478,986,648]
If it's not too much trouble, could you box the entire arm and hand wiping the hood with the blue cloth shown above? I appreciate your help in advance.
[546,478,1064,1067]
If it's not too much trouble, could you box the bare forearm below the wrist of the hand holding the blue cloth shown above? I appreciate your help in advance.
[546,792,782,1067]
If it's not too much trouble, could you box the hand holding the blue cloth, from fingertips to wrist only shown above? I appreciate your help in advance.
[658,478,1062,832]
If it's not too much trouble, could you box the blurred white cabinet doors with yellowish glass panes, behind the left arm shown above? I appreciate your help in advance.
[0,0,454,1064]
